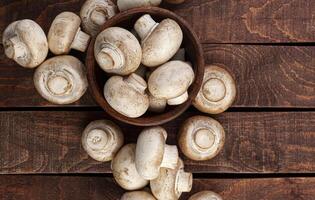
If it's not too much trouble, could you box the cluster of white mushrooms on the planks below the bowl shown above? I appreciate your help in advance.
[82,116,225,200]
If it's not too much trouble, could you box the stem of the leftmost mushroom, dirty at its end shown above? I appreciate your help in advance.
[5,36,31,64]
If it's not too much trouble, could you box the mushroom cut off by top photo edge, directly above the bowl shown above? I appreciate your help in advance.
[117,0,162,11]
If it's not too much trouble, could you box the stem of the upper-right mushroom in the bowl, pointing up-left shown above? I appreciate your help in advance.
[134,14,159,41]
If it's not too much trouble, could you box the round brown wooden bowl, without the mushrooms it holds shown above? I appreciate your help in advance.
[86,7,204,126]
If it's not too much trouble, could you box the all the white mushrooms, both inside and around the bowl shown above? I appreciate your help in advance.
[2,0,236,200]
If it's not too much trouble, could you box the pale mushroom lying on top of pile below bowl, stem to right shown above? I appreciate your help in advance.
[135,127,178,180]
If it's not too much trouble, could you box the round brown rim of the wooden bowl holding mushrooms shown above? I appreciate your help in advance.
[85,7,205,126]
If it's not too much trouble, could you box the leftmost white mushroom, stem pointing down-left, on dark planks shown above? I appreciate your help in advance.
[2,19,48,68]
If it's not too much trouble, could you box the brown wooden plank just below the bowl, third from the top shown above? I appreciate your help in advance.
[0,109,315,174]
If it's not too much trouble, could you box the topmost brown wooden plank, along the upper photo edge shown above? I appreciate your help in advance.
[0,0,315,43]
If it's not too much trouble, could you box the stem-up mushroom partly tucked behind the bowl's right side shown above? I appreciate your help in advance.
[193,65,236,114]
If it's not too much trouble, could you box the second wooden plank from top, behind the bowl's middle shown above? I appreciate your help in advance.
[0,45,315,108]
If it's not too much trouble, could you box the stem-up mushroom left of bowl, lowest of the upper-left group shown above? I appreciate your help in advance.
[33,55,88,104]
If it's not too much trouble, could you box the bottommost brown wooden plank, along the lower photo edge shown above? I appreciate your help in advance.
[0,176,315,200]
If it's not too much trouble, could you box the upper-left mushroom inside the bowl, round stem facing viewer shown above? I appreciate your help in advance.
[94,27,142,75]
